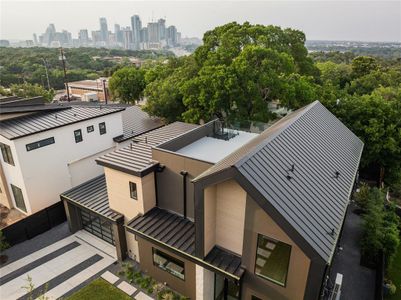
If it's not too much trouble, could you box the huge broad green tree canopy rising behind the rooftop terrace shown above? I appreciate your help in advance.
[145,22,319,122]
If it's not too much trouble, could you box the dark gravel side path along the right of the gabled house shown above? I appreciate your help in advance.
[324,204,376,300]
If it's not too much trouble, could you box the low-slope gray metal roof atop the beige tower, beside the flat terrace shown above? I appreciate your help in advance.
[96,122,198,176]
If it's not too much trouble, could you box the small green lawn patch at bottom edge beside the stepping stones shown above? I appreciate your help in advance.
[67,278,131,300]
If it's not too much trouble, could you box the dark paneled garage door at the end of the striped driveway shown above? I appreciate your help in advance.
[80,210,115,245]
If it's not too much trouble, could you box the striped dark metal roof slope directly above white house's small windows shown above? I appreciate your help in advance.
[0,106,124,140]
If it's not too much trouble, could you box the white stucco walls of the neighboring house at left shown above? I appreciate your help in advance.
[0,112,123,214]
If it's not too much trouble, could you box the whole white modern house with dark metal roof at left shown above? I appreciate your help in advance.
[0,97,162,215]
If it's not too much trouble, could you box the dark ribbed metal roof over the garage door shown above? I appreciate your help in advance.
[61,174,124,221]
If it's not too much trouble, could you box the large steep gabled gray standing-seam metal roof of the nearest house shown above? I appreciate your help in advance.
[195,101,363,262]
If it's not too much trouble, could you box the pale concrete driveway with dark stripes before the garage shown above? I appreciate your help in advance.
[0,231,116,300]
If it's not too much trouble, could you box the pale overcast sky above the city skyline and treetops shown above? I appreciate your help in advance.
[0,0,401,42]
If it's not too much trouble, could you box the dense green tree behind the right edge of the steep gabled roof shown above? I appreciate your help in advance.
[324,90,401,184]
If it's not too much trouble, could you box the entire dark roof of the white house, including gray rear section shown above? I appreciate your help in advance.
[0,97,164,143]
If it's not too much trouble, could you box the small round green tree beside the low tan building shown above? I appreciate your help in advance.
[109,67,146,103]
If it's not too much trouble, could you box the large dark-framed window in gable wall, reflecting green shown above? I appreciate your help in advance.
[255,234,291,286]
